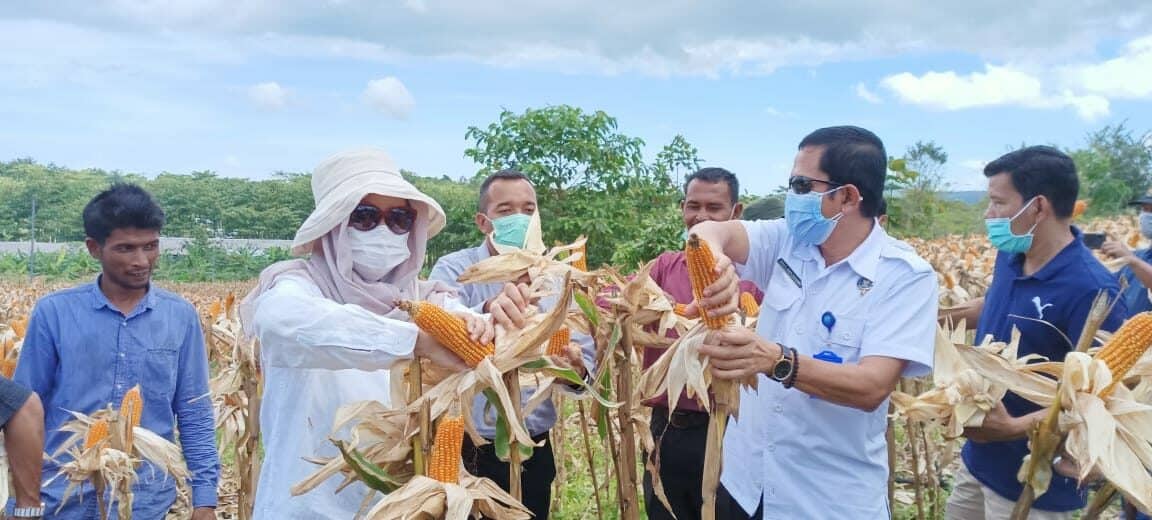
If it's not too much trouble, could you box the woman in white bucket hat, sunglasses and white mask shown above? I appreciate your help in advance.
[241,149,493,519]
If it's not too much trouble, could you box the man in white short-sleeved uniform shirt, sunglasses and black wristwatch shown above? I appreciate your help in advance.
[690,127,938,519]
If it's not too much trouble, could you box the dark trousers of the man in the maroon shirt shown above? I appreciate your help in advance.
[644,407,708,520]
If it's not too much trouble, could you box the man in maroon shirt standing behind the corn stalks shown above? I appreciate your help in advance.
[644,167,763,520]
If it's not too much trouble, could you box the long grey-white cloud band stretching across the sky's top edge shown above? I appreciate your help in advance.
[0,0,1152,76]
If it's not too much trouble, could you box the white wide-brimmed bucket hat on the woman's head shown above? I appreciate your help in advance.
[291,148,445,255]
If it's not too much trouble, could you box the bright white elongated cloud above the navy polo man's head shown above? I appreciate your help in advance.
[880,65,1109,120]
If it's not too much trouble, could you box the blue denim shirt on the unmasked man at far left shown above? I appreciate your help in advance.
[14,279,220,519]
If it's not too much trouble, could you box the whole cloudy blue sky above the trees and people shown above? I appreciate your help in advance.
[0,0,1152,195]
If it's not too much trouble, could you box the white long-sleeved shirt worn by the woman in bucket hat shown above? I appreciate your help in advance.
[252,274,463,520]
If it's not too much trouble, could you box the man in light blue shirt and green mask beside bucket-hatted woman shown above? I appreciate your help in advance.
[429,169,596,519]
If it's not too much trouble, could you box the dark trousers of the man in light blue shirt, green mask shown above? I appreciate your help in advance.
[461,432,556,520]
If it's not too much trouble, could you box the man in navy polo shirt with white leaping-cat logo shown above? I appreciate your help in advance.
[946,146,1127,520]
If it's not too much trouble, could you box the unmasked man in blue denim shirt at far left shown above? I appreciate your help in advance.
[15,184,220,520]
